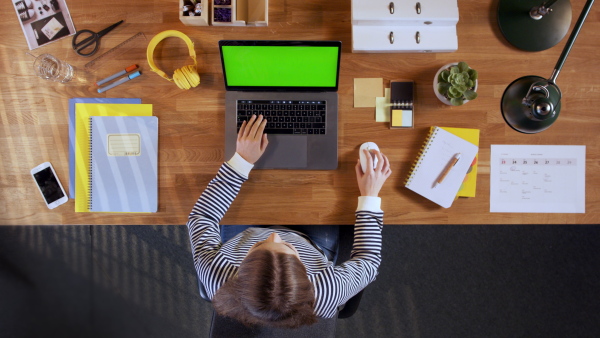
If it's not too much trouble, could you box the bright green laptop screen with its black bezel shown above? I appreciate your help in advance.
[219,41,340,91]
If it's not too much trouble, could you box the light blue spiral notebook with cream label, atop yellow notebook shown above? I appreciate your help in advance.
[89,116,158,212]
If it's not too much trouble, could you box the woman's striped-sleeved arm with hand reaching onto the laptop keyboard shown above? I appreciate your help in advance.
[187,116,268,294]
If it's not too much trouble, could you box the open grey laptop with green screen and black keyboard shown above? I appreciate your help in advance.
[219,40,342,170]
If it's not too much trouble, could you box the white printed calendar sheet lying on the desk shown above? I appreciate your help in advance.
[490,145,585,213]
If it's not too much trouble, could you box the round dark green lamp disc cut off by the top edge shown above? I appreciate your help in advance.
[498,0,572,52]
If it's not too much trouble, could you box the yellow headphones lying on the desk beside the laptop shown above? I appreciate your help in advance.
[146,30,200,89]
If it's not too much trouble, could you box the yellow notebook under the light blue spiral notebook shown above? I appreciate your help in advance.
[75,103,152,212]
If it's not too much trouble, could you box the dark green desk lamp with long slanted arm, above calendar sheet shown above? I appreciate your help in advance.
[500,0,594,134]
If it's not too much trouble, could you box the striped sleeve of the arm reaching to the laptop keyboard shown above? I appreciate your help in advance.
[187,163,247,298]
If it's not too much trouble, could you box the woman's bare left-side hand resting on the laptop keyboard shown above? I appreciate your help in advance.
[236,115,269,164]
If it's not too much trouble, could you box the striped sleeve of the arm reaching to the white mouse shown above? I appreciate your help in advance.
[313,210,383,318]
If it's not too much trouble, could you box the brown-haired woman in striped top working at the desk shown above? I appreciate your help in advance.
[187,115,392,328]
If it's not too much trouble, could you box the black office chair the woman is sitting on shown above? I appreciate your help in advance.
[198,226,364,338]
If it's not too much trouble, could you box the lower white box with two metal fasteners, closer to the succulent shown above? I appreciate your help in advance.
[352,25,458,53]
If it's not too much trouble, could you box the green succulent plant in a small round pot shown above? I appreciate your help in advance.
[437,61,478,106]
